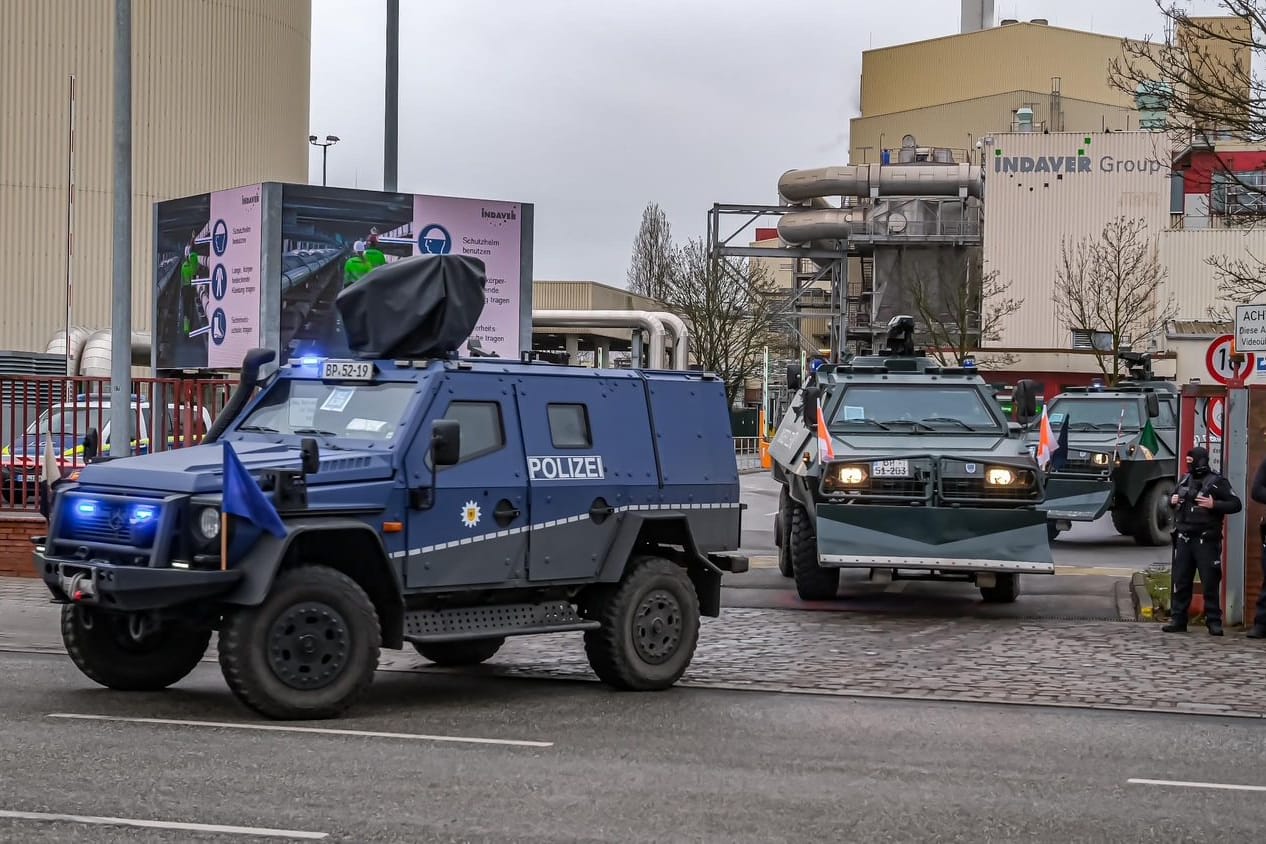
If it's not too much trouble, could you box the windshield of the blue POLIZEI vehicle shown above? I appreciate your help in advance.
[237,378,415,442]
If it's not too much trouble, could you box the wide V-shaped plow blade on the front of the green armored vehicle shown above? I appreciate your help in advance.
[815,504,1055,574]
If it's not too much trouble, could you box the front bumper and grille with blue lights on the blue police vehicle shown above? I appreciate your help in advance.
[33,491,242,612]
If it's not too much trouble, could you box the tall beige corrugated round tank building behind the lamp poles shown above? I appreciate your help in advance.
[0,0,311,366]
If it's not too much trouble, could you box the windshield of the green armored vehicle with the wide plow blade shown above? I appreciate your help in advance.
[829,383,1001,433]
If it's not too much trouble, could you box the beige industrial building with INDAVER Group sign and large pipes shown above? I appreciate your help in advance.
[709,0,1266,407]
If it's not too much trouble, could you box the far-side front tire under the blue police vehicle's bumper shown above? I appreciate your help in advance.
[62,604,211,692]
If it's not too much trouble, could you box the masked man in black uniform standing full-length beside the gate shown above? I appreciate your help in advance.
[1161,445,1244,636]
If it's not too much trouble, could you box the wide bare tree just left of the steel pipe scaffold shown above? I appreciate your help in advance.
[663,239,784,404]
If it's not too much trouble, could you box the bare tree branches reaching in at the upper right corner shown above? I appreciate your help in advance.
[1109,0,1266,299]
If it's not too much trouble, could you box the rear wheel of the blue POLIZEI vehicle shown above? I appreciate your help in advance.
[585,557,699,691]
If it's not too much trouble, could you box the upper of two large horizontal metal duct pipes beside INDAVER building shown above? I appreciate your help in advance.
[779,164,985,204]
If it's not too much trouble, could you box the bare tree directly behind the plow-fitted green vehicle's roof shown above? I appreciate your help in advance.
[909,249,1024,367]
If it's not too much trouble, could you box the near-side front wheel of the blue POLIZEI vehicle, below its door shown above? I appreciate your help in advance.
[219,566,382,720]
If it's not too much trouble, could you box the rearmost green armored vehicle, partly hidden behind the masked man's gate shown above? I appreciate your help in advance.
[1029,352,1179,545]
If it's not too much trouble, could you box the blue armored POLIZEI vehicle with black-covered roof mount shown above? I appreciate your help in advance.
[35,256,747,719]
